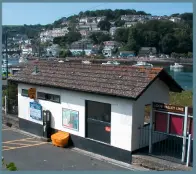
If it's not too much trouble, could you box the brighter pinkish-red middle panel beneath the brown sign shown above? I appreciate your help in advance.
[169,115,184,135]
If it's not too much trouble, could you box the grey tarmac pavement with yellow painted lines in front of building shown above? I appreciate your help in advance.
[2,126,149,171]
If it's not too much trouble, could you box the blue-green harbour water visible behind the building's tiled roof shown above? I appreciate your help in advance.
[4,59,193,90]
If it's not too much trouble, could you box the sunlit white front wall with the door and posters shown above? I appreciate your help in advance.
[18,84,133,151]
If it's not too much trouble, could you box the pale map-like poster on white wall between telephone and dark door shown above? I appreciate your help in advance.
[62,109,79,131]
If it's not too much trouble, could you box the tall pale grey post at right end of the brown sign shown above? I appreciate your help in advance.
[181,106,188,162]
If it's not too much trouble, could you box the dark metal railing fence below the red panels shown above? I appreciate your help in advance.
[139,125,193,165]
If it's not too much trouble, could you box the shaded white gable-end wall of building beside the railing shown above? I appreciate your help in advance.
[131,79,169,151]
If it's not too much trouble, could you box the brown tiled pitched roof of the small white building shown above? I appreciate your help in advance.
[9,61,183,99]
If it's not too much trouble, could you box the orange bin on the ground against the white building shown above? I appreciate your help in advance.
[51,131,69,147]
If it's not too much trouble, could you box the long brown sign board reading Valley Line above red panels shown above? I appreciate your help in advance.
[153,103,185,114]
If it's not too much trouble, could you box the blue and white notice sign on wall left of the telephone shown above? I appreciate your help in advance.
[30,102,42,121]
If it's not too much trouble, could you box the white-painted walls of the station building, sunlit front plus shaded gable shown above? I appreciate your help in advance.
[18,77,169,151]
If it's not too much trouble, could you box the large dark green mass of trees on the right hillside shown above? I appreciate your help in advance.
[121,17,193,55]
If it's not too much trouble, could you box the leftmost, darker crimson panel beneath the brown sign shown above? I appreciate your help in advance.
[155,112,167,132]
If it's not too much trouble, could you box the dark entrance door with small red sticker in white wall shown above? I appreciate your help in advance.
[85,101,111,144]
